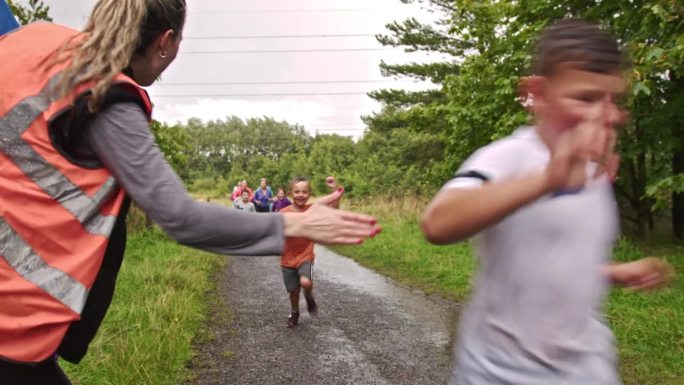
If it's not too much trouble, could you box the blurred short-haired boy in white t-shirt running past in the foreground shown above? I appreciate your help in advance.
[422,19,668,385]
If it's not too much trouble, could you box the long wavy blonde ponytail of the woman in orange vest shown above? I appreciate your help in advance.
[53,0,146,112]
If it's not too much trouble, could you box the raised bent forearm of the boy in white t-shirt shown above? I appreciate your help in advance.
[421,173,550,245]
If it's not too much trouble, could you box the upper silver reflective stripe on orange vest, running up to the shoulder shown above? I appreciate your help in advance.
[0,76,117,236]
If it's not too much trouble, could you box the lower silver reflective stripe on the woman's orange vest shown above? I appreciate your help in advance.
[0,218,88,314]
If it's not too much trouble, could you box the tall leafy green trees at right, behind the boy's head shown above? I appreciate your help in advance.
[374,0,684,237]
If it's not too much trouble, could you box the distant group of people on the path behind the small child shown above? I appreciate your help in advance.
[230,178,292,213]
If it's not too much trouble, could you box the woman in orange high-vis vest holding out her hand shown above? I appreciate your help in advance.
[0,0,379,385]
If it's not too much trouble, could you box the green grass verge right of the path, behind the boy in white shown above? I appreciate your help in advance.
[336,197,684,385]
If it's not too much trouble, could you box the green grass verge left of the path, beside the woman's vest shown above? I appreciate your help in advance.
[61,232,225,385]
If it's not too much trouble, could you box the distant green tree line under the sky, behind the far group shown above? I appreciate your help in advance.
[153,116,432,197]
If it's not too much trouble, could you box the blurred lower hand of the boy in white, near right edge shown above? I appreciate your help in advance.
[608,257,675,290]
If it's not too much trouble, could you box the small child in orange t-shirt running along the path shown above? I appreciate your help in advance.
[280,176,343,328]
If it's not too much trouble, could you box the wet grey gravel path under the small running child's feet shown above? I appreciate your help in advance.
[193,246,457,385]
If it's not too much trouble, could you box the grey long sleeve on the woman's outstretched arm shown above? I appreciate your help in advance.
[84,103,285,255]
